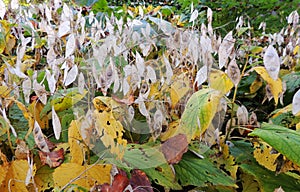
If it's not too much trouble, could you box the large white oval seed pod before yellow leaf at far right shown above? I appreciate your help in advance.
[263,45,280,81]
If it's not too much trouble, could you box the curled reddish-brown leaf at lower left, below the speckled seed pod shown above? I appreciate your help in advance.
[39,148,64,168]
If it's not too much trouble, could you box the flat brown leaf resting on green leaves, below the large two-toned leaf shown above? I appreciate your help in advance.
[161,134,188,164]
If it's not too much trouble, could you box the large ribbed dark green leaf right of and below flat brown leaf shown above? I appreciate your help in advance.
[174,153,235,187]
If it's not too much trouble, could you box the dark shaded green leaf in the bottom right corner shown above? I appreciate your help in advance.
[240,162,300,192]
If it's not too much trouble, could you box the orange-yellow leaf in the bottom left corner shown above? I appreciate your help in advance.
[0,160,35,191]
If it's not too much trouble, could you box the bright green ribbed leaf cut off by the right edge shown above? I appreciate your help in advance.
[249,123,300,165]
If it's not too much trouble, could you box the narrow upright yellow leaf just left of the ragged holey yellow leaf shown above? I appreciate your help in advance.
[68,120,84,165]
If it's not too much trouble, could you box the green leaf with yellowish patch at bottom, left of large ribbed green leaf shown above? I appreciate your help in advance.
[143,164,182,190]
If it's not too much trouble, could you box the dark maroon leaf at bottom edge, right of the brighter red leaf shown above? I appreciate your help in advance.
[129,169,153,192]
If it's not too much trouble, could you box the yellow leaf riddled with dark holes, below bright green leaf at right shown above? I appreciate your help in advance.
[253,141,280,171]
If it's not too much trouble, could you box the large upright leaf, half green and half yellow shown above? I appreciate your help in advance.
[178,89,222,142]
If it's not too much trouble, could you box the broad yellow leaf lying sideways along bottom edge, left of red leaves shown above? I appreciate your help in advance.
[53,163,112,189]
